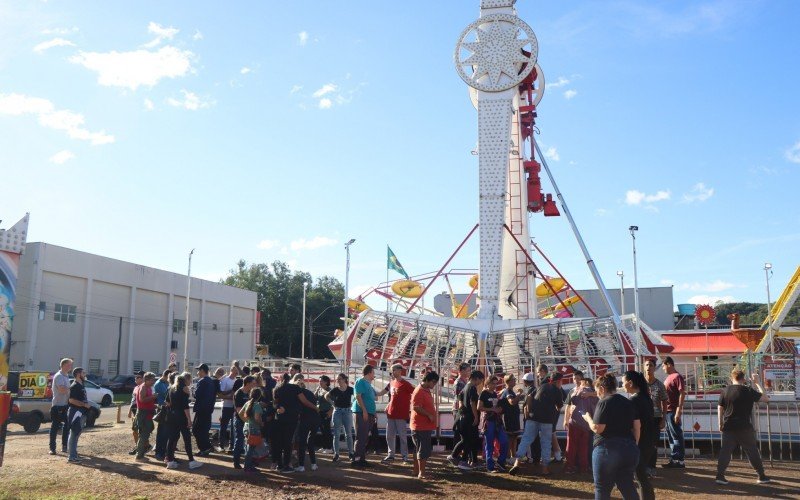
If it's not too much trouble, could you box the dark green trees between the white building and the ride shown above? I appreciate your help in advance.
[222,260,344,358]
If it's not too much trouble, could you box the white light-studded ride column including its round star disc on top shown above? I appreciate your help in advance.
[454,0,538,319]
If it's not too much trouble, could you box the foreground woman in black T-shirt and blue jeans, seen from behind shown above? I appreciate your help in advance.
[583,373,640,500]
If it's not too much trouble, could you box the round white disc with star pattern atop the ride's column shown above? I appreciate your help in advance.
[454,14,539,92]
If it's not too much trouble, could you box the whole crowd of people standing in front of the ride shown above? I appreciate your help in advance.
[50,357,769,499]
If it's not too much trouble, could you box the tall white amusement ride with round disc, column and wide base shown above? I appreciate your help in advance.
[329,0,665,381]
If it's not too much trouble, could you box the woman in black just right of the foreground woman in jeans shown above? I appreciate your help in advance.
[622,370,658,500]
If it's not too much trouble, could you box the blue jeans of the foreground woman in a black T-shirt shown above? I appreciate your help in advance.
[592,436,639,500]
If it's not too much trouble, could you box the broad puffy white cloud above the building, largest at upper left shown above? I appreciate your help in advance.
[69,45,194,90]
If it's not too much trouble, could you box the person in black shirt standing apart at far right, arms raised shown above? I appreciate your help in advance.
[716,368,770,485]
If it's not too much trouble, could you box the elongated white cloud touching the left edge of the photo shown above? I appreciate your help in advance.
[0,94,114,145]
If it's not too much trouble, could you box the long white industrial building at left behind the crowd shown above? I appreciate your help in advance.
[9,243,257,377]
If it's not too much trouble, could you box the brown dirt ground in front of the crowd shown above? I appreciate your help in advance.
[0,410,800,500]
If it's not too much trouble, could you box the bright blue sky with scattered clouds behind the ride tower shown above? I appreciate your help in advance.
[0,0,800,312]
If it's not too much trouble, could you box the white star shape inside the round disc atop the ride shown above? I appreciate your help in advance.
[462,21,531,87]
